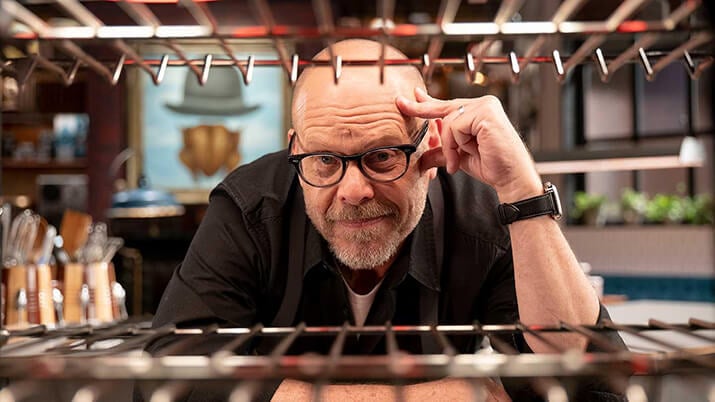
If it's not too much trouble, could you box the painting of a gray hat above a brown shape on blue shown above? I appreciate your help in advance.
[141,53,286,190]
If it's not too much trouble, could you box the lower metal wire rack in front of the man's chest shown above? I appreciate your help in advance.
[0,318,715,402]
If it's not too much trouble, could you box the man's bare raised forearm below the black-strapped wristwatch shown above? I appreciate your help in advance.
[509,216,599,353]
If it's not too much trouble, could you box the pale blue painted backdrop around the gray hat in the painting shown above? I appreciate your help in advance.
[141,54,285,189]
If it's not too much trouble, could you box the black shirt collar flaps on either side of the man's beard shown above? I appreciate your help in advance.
[303,196,443,291]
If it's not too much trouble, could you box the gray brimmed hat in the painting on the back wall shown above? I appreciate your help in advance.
[166,67,259,116]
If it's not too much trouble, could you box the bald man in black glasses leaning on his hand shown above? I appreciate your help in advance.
[154,40,628,400]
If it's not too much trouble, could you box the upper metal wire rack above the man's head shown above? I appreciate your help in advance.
[0,0,713,85]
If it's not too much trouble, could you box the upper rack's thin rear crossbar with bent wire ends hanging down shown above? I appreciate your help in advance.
[5,47,713,89]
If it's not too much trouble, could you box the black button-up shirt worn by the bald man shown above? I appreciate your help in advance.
[154,151,618,400]
